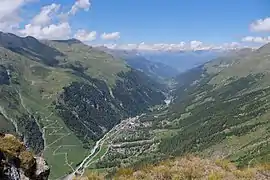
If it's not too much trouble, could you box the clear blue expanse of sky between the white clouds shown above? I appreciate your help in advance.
[73,0,270,43]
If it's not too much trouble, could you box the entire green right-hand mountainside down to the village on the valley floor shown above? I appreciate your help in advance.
[91,45,270,173]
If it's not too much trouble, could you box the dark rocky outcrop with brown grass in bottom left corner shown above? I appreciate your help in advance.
[0,133,50,180]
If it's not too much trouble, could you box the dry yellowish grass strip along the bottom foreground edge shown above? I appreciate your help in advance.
[77,155,270,180]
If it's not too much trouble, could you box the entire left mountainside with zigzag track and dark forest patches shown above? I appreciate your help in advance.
[0,33,165,179]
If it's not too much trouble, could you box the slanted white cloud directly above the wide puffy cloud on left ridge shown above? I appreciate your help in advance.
[32,3,61,26]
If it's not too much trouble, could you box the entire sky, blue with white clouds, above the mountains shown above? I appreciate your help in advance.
[0,0,270,50]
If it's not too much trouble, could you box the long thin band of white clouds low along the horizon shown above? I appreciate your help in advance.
[98,41,241,51]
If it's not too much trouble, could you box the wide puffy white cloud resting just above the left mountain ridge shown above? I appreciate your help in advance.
[19,22,71,39]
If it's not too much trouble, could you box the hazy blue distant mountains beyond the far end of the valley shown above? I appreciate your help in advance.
[98,47,233,74]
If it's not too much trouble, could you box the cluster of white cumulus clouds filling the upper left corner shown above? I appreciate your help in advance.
[0,0,96,41]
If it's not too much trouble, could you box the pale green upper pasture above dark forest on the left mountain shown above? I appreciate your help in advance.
[45,41,129,85]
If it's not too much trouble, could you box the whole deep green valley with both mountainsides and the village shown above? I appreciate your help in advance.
[0,33,270,179]
